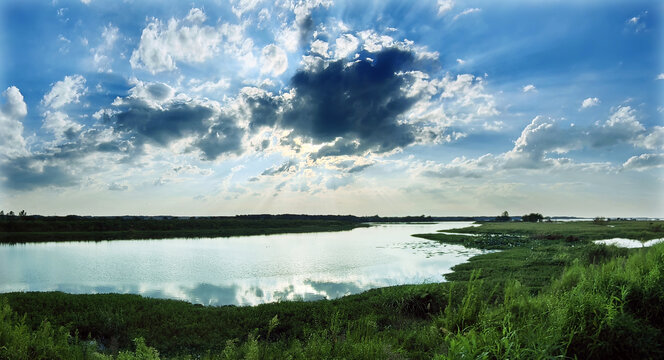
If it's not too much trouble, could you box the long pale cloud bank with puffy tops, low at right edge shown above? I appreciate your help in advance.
[415,106,664,178]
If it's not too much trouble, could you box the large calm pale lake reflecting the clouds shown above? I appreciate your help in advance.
[0,222,485,305]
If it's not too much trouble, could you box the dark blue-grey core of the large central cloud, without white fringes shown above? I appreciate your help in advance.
[281,48,418,157]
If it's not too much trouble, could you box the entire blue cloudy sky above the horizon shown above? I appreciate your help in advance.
[0,0,664,217]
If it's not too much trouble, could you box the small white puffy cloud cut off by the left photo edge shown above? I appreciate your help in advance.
[0,86,28,160]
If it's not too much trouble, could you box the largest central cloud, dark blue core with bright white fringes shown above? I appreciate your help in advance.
[232,43,499,160]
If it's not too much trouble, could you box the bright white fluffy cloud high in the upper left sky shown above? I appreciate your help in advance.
[129,8,222,74]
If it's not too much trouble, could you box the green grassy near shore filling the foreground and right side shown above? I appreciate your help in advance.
[0,221,664,359]
